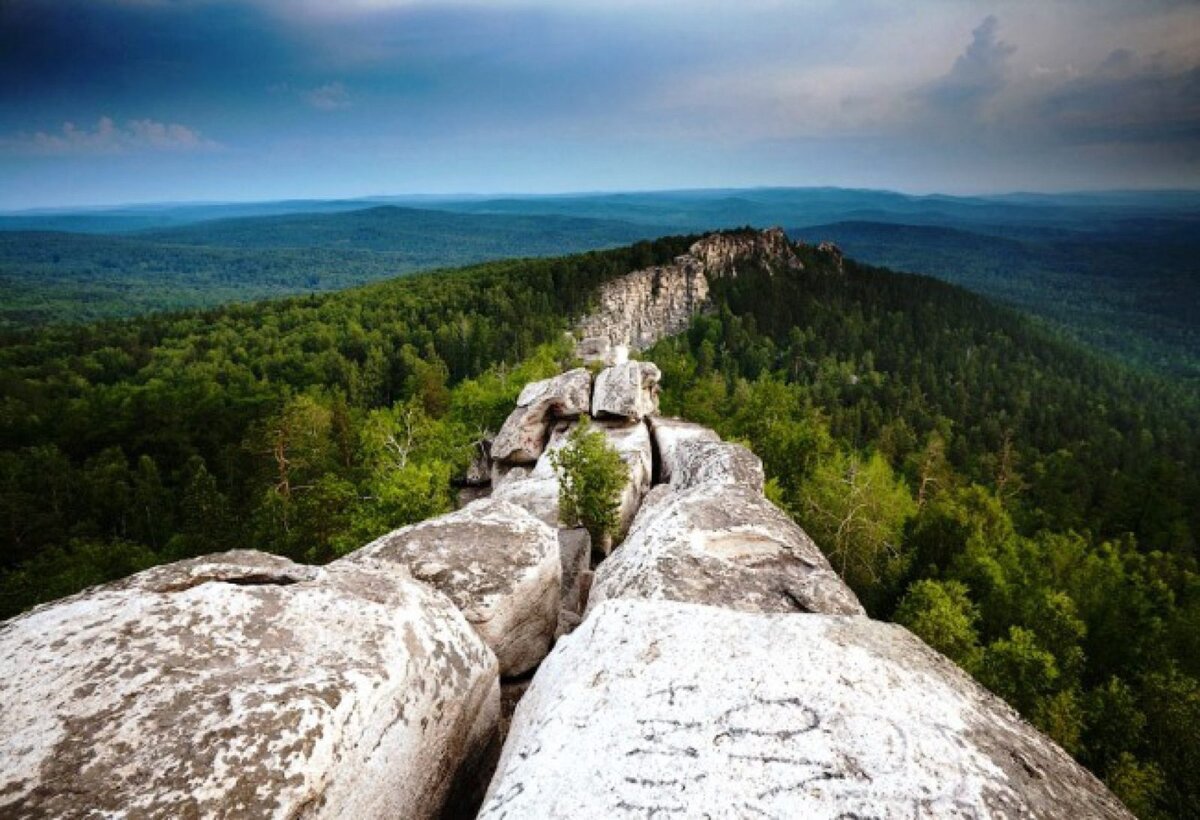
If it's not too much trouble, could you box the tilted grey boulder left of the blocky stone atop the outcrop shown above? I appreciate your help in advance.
[491,367,592,463]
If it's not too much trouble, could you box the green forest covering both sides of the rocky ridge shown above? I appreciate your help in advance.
[0,237,1200,818]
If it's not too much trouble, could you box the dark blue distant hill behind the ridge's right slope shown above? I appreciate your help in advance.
[791,219,1200,384]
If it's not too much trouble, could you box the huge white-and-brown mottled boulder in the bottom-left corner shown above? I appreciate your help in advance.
[0,551,499,819]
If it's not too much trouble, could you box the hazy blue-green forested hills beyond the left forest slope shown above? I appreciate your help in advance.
[0,207,667,330]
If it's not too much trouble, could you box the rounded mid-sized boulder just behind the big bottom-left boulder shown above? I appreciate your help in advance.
[338,498,563,677]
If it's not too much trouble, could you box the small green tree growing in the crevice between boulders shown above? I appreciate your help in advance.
[550,419,629,545]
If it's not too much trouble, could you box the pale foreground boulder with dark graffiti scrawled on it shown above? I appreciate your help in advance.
[479,600,1132,820]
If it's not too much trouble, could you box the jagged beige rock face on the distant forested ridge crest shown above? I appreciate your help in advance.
[578,228,803,352]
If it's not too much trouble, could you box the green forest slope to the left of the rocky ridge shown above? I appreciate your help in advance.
[0,232,689,616]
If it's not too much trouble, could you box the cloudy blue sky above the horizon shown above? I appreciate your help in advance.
[0,0,1200,210]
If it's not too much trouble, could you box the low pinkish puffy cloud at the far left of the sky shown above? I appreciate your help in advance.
[0,116,220,156]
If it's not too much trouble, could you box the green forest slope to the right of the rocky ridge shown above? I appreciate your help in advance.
[647,242,1200,816]
